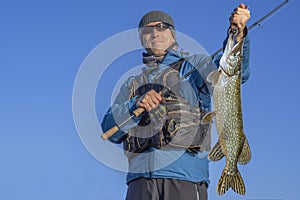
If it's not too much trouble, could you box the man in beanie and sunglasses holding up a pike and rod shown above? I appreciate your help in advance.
[102,4,250,200]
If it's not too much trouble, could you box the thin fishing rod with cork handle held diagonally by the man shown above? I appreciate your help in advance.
[101,0,289,140]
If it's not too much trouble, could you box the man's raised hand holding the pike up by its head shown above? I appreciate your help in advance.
[229,4,250,41]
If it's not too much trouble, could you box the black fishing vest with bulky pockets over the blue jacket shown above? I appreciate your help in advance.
[123,59,210,158]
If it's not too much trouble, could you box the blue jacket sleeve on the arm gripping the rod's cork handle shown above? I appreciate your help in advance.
[101,79,141,143]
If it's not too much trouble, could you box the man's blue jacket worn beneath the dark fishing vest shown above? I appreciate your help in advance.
[101,36,250,183]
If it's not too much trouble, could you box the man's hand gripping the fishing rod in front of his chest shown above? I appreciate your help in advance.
[137,90,163,112]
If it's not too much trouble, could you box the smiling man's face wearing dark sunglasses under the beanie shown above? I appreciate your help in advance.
[140,22,175,55]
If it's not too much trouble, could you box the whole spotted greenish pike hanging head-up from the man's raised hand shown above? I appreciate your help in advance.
[203,31,251,195]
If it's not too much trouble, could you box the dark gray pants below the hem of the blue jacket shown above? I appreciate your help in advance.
[126,178,207,200]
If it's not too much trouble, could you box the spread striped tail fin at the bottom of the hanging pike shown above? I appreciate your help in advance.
[217,168,246,195]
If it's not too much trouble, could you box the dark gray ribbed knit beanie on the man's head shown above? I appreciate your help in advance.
[139,10,176,39]
